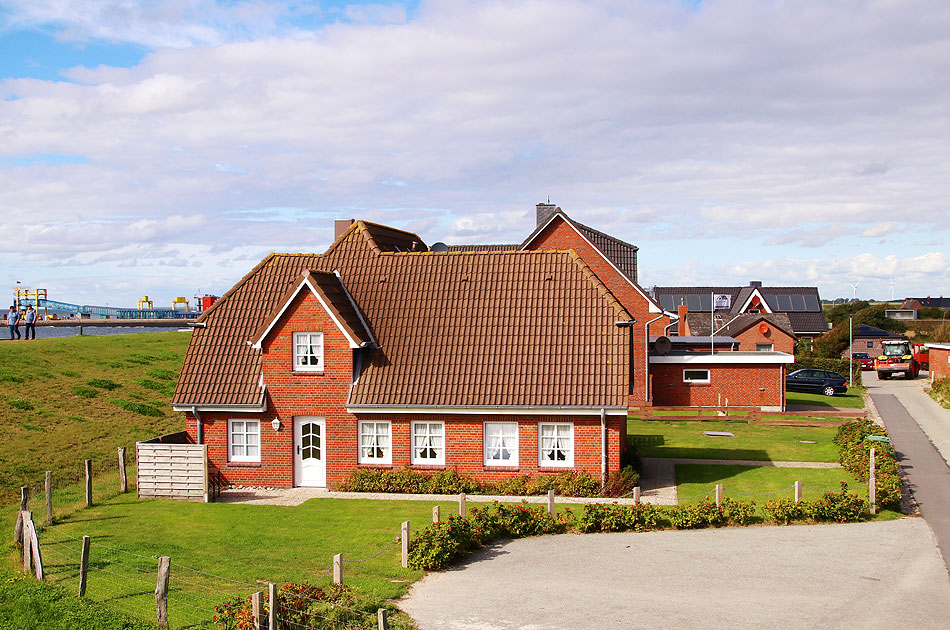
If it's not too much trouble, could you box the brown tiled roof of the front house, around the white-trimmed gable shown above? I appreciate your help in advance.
[173,221,632,407]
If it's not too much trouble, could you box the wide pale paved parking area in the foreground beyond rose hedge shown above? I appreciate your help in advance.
[400,518,950,630]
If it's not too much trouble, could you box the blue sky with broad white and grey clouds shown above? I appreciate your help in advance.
[0,0,950,305]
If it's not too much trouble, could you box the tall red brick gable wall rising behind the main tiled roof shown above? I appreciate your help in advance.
[528,218,670,403]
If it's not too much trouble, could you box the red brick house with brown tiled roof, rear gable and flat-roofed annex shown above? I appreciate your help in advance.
[172,204,792,487]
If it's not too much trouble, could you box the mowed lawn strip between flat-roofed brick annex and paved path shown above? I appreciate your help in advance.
[627,418,838,462]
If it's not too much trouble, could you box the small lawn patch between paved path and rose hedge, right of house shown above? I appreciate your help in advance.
[676,464,901,520]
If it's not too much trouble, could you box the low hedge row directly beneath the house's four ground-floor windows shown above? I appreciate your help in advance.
[340,466,640,497]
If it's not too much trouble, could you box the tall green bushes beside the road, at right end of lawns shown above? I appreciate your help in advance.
[834,419,901,510]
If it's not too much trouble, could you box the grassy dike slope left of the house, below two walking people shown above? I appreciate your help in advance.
[0,332,190,503]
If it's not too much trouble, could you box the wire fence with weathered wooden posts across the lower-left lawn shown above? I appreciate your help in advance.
[29,526,411,630]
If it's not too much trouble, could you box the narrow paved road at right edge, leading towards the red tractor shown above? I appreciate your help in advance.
[865,376,950,568]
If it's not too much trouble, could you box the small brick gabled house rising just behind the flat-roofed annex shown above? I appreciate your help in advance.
[680,307,795,354]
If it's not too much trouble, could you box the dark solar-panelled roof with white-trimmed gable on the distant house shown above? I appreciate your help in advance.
[653,281,828,340]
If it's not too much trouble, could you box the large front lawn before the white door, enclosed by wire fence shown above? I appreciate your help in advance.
[4,493,458,627]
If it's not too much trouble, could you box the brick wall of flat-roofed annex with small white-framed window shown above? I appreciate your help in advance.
[650,364,785,407]
